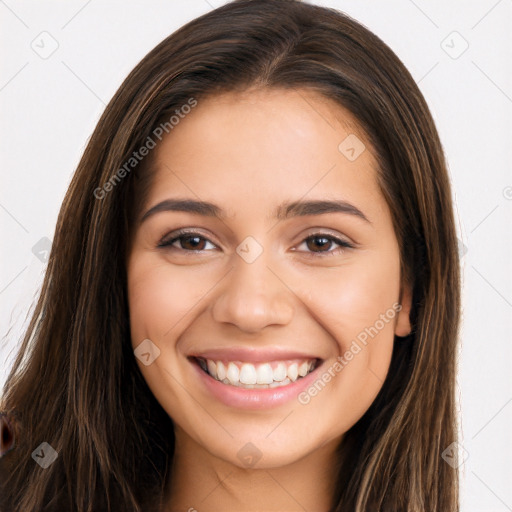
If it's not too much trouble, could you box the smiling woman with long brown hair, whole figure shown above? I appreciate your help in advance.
[0,0,460,512]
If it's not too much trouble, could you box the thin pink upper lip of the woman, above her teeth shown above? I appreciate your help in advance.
[189,347,319,363]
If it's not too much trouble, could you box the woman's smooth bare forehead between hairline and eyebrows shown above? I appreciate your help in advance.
[144,89,382,222]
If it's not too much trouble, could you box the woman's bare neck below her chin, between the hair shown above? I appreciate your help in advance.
[164,426,340,512]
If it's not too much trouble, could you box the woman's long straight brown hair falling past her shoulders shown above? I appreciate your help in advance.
[0,0,460,512]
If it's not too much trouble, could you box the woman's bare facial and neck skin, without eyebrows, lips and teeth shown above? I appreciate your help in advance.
[127,89,411,512]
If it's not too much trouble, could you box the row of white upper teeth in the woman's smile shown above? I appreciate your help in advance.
[198,358,315,388]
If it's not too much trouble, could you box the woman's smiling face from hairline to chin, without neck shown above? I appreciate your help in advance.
[128,90,410,467]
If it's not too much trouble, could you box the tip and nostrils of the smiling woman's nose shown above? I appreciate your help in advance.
[212,251,294,333]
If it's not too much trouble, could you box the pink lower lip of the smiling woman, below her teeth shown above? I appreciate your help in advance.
[191,359,321,409]
